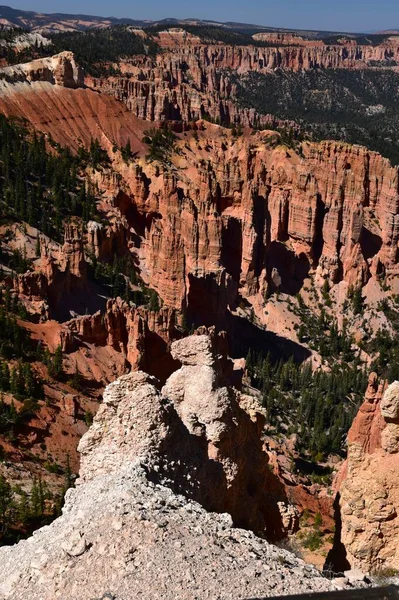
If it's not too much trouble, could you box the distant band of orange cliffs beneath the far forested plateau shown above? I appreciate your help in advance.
[86,29,399,126]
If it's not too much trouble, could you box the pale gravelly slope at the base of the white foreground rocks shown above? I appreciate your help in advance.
[0,463,340,600]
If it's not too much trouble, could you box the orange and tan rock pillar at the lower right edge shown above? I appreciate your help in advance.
[339,375,399,572]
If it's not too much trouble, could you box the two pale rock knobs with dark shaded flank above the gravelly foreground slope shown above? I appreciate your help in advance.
[80,334,297,539]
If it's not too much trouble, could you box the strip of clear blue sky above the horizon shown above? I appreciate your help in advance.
[3,0,399,31]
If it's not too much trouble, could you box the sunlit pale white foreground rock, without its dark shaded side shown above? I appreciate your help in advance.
[0,336,335,600]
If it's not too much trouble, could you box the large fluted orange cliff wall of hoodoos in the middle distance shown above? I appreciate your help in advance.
[117,125,399,316]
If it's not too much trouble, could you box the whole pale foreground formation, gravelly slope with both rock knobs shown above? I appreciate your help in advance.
[0,335,342,600]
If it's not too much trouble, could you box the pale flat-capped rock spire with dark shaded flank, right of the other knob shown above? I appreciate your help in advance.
[162,335,298,539]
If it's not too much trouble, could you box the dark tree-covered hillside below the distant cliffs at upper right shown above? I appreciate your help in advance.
[234,65,399,164]
